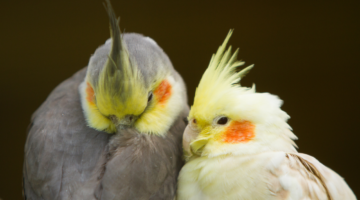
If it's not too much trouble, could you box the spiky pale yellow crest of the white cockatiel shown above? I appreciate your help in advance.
[190,30,255,122]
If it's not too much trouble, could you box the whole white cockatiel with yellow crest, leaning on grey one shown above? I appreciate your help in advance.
[177,31,356,200]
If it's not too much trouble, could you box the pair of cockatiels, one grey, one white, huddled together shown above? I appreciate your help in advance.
[23,1,356,200]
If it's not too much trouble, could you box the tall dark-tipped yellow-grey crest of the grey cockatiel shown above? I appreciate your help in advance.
[94,1,146,111]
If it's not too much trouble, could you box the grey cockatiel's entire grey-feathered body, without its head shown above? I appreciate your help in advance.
[23,65,188,199]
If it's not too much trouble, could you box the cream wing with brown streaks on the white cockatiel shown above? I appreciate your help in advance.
[267,153,356,200]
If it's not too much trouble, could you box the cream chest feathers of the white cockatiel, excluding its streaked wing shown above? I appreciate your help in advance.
[178,153,278,200]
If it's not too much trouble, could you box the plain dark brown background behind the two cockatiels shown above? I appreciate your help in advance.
[0,0,360,200]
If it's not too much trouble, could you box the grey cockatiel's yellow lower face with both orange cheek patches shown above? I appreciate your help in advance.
[81,77,176,134]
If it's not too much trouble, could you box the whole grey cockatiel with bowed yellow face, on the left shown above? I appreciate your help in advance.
[23,1,189,200]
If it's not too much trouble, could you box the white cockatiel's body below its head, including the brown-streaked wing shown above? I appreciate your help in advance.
[178,152,354,200]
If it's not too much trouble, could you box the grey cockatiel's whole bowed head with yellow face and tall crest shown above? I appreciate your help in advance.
[79,1,187,134]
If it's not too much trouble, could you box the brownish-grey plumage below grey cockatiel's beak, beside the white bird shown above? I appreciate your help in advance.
[96,110,187,200]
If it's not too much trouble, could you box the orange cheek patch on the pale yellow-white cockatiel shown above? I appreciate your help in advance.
[223,120,255,143]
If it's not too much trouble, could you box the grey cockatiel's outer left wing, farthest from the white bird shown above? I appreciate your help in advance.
[23,68,109,199]
